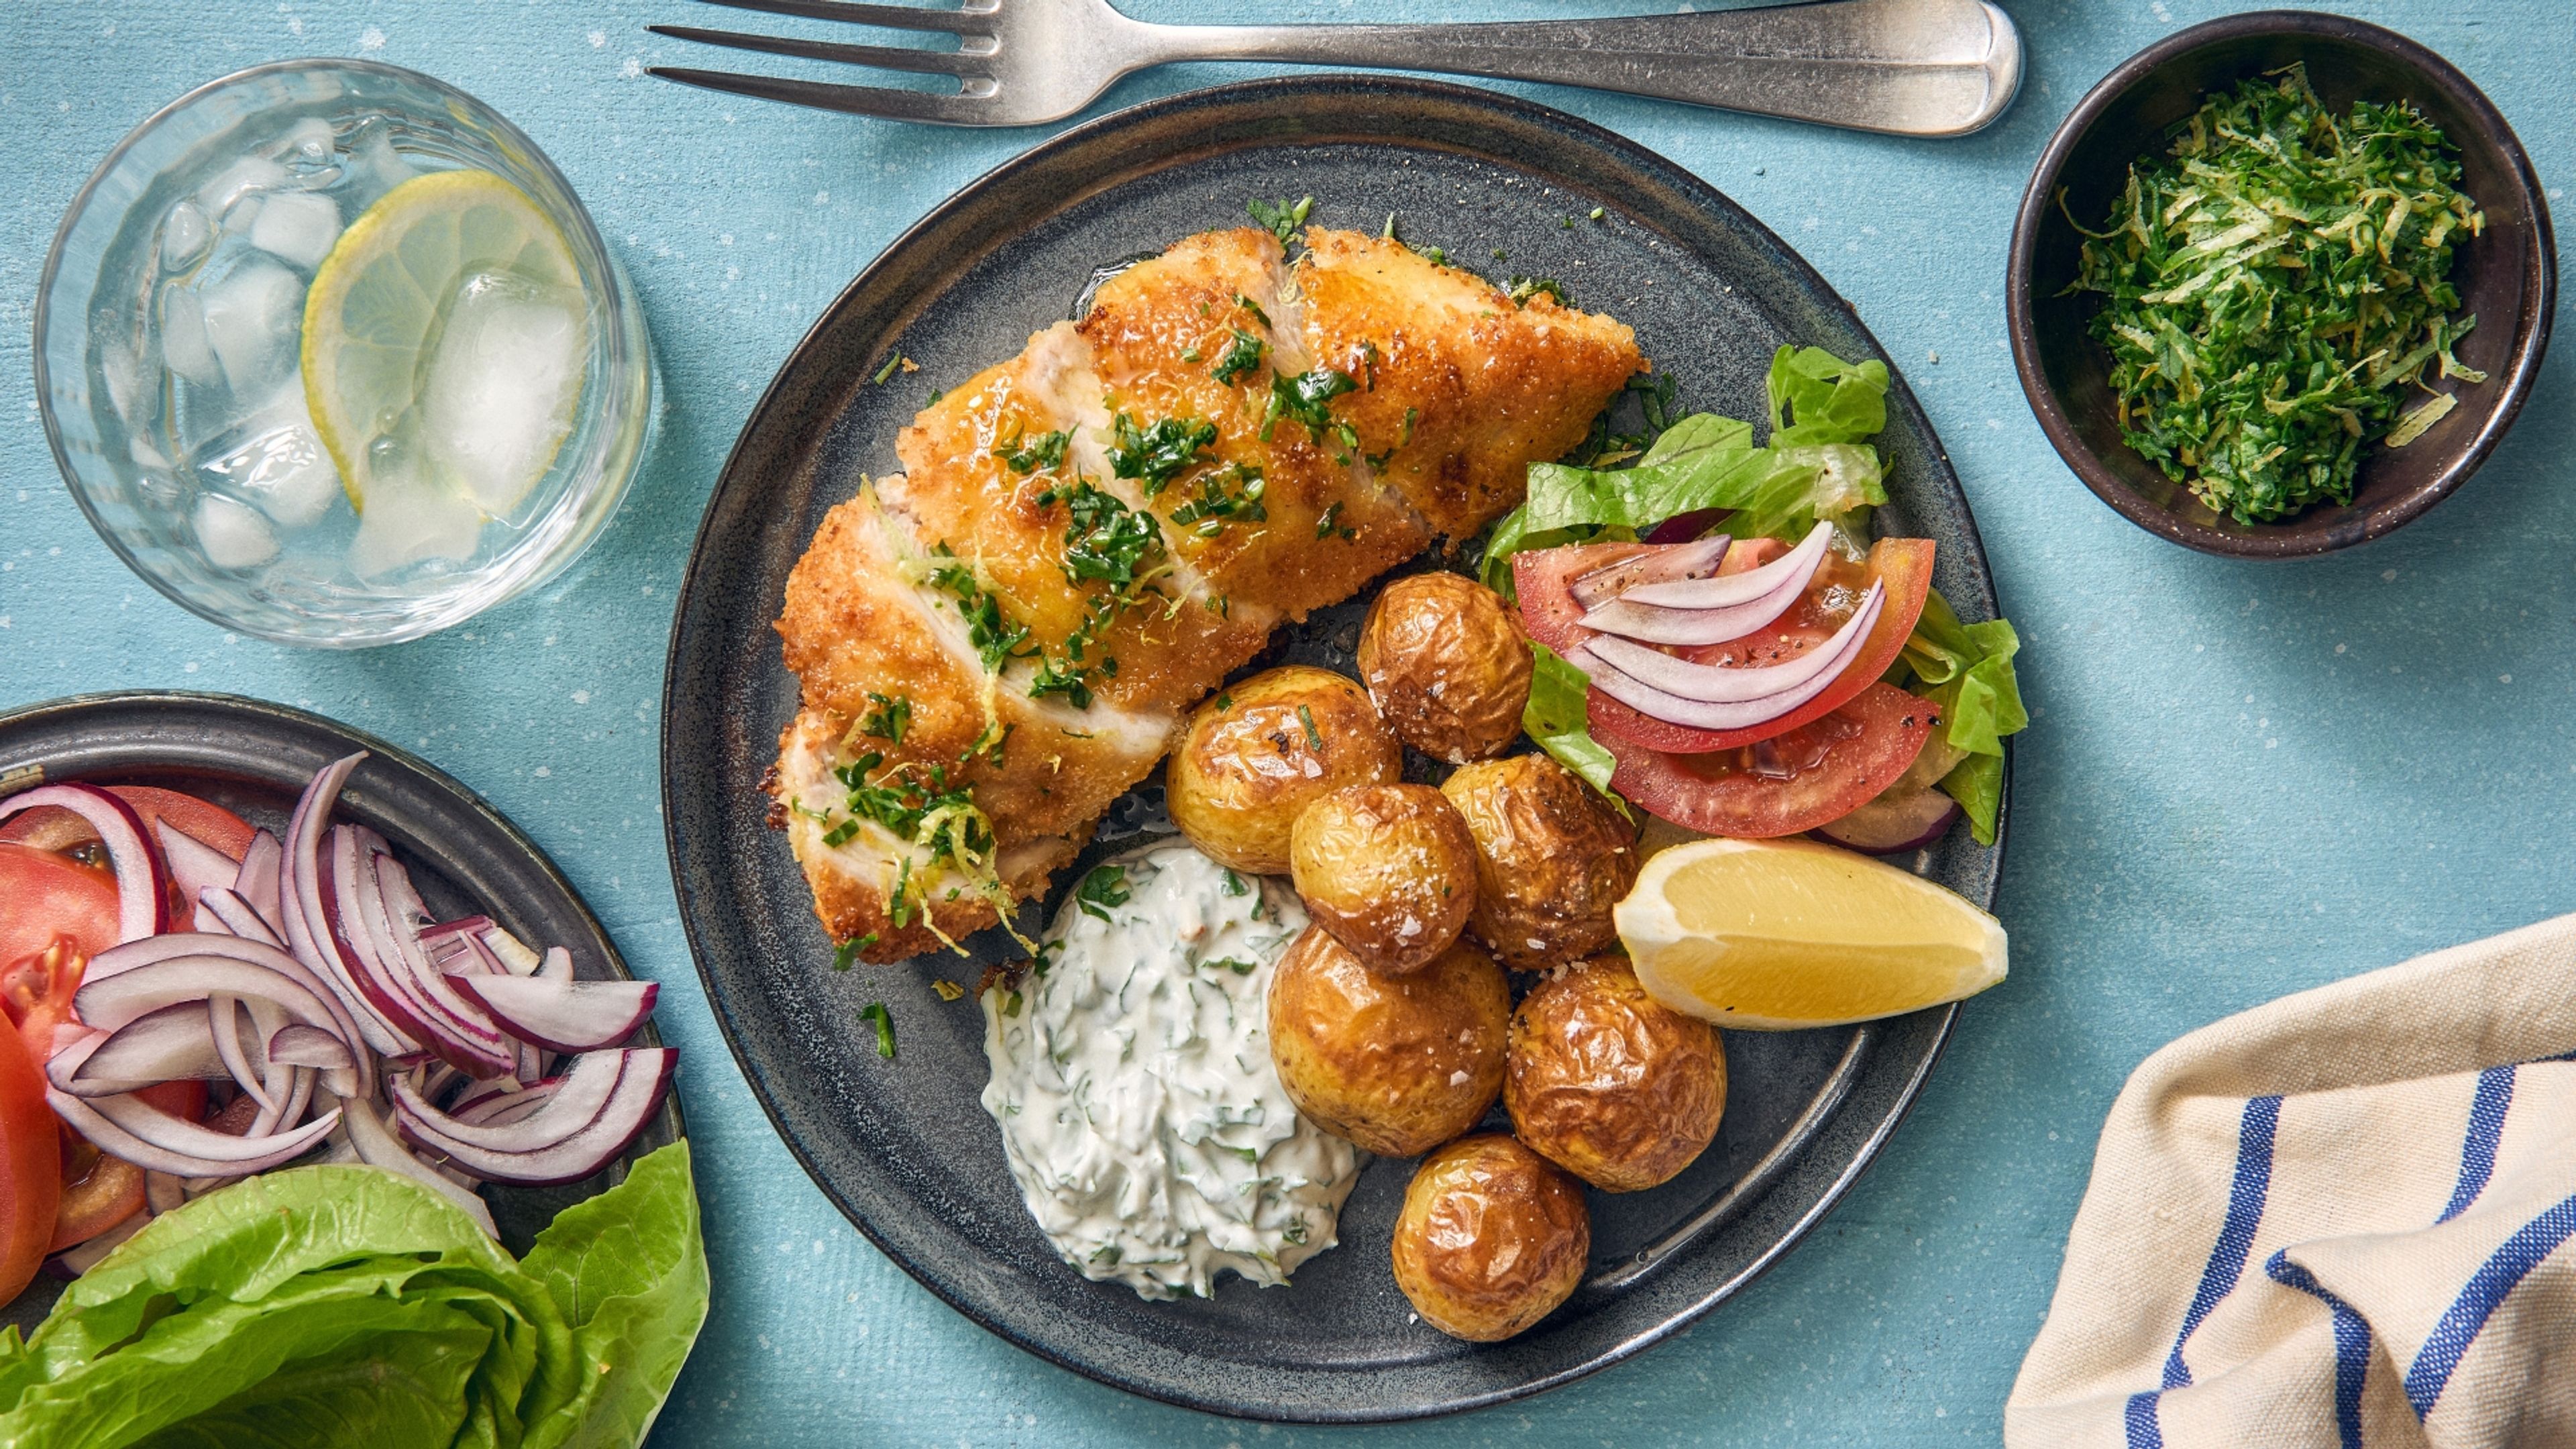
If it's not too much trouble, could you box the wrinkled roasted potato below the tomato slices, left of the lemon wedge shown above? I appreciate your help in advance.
[1440,755,1641,972]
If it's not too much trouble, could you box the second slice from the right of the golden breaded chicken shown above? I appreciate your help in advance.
[1082,227,1430,624]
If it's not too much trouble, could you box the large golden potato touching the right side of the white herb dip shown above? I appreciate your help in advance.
[1270,926,1512,1158]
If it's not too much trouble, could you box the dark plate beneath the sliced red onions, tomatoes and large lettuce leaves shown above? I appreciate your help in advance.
[0,691,683,1330]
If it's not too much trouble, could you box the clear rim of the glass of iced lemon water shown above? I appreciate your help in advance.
[28,57,654,650]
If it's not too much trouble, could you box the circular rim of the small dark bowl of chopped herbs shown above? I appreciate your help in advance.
[2004,10,2558,559]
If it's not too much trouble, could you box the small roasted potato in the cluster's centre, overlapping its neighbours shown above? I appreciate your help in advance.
[1288,784,1476,972]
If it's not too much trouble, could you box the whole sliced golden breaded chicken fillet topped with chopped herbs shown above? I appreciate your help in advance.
[767,227,1641,962]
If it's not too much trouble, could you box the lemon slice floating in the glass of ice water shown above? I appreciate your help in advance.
[301,170,590,519]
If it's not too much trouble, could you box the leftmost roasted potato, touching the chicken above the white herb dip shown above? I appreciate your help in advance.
[1165,665,1404,877]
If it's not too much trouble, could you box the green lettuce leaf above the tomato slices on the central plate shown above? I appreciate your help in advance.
[1481,348,1888,598]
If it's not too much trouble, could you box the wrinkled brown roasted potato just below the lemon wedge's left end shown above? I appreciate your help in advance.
[1502,957,1726,1191]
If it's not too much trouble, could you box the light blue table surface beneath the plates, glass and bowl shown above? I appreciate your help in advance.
[0,0,2576,1449]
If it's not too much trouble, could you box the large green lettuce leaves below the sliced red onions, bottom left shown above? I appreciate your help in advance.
[0,1144,706,1449]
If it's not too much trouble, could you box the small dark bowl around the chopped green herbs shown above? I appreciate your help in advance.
[2004,10,2558,559]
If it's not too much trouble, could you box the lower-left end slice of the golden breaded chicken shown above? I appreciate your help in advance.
[770,485,1177,959]
